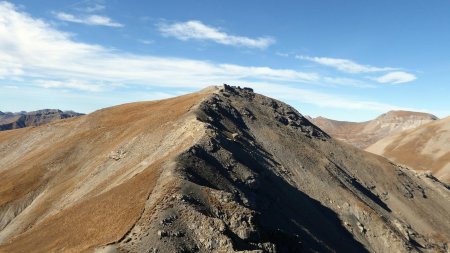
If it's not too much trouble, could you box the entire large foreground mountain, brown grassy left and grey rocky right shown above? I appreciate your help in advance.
[0,85,450,253]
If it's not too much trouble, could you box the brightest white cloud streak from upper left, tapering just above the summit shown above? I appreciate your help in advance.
[0,3,318,91]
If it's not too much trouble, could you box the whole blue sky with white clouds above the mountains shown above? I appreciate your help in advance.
[0,0,450,121]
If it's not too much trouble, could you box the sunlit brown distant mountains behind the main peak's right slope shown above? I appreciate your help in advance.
[310,111,450,183]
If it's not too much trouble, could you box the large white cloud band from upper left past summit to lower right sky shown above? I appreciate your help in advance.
[0,2,414,111]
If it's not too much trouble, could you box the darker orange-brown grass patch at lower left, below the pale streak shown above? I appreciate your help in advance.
[0,158,161,252]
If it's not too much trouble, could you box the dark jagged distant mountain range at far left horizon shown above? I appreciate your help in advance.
[0,109,83,131]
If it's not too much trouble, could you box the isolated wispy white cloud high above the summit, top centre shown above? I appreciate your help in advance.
[158,20,275,49]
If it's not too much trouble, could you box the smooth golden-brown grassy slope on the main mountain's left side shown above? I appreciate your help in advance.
[0,92,208,252]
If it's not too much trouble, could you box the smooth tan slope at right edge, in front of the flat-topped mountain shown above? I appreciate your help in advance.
[367,117,450,183]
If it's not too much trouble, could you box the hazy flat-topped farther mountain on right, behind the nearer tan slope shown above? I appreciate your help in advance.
[311,111,437,149]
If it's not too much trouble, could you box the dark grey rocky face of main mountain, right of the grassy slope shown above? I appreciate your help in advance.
[117,85,446,253]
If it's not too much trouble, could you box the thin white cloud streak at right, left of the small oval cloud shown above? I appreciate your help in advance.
[296,55,395,73]
